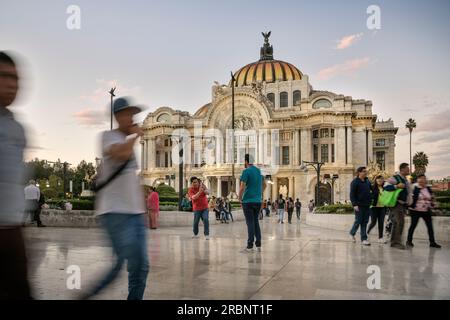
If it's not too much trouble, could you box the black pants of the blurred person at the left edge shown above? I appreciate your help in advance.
[0,228,32,300]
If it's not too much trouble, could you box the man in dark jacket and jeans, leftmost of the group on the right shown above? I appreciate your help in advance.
[350,167,372,246]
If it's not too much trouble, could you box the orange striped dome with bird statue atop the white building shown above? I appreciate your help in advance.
[234,31,303,87]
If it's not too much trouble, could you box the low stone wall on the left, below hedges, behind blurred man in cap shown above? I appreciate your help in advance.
[41,209,244,228]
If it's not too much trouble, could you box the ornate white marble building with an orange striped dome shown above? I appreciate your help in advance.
[141,33,398,204]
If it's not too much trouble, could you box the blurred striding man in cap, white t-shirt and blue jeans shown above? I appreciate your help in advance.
[84,98,149,300]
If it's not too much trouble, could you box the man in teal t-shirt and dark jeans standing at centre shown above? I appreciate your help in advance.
[239,154,266,252]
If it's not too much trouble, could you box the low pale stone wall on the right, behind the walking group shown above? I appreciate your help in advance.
[306,212,450,241]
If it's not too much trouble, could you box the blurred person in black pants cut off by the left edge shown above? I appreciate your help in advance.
[0,51,31,300]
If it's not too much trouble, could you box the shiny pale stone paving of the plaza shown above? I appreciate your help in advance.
[25,212,450,299]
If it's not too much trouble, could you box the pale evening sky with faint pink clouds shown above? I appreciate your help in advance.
[0,0,450,178]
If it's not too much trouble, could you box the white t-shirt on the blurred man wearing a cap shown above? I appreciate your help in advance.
[96,130,145,215]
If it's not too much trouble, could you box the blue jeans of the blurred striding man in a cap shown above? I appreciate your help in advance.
[92,213,150,300]
